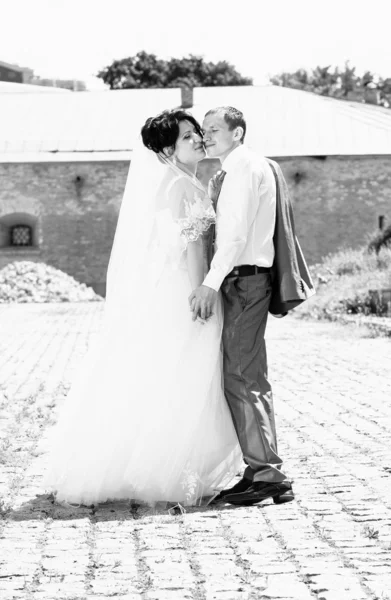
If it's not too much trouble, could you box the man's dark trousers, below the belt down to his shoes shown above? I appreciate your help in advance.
[221,273,286,482]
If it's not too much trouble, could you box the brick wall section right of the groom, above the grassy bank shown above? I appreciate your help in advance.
[276,156,391,263]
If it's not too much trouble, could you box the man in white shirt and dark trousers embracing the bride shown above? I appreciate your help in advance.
[189,106,294,506]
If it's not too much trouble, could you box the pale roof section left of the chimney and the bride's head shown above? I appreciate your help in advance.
[0,89,180,161]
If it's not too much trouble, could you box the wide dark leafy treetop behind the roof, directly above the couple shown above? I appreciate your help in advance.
[98,51,253,90]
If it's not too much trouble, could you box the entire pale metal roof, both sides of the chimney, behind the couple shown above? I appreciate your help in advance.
[0,84,391,162]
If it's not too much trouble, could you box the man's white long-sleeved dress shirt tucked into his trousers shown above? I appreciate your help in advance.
[203,145,276,291]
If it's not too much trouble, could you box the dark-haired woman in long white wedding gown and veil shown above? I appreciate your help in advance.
[44,109,242,505]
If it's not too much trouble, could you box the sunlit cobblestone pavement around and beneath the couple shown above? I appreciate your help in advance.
[0,303,391,600]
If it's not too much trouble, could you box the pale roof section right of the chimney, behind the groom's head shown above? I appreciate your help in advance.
[193,85,391,157]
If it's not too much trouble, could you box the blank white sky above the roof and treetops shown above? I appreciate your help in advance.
[0,0,391,89]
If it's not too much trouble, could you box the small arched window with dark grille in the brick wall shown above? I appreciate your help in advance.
[0,213,38,249]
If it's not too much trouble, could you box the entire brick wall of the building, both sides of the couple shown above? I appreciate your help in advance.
[0,157,391,291]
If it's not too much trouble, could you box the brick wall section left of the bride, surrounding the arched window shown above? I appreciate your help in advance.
[0,161,127,290]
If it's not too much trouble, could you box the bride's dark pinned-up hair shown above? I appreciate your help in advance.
[141,108,202,153]
